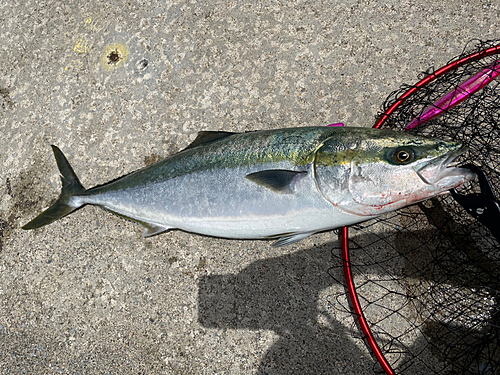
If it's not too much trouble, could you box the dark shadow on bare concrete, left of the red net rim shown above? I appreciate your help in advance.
[198,245,373,374]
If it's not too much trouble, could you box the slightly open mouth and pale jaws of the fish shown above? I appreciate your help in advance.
[415,146,475,189]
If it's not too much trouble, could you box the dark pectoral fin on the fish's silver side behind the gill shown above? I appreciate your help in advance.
[245,169,307,194]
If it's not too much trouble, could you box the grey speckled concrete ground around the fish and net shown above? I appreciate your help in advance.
[0,0,500,374]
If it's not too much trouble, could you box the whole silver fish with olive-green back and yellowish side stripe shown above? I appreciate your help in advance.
[22,126,475,246]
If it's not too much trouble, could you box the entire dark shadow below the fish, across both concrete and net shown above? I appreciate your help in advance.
[198,198,500,375]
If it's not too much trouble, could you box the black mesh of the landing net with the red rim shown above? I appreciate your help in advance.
[332,40,500,374]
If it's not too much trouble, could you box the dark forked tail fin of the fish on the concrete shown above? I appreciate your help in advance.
[23,146,85,229]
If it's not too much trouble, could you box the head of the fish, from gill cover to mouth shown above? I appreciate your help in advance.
[314,129,475,216]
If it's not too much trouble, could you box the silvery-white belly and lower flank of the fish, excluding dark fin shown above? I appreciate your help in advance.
[74,165,368,238]
